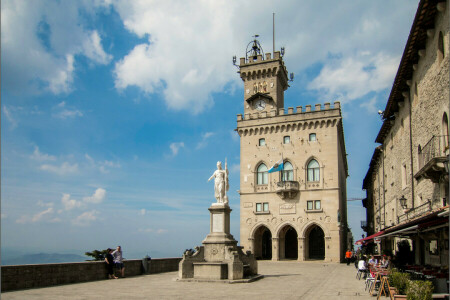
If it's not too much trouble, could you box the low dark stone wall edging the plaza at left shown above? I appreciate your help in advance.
[1,258,181,292]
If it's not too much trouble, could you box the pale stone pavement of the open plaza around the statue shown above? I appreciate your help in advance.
[1,261,378,300]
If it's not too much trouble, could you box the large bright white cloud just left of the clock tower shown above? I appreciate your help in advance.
[114,1,235,113]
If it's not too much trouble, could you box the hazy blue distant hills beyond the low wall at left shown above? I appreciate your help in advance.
[2,253,89,266]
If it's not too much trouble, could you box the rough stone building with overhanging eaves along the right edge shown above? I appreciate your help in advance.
[358,0,450,266]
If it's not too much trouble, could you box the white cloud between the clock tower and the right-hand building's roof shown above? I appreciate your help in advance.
[308,53,399,102]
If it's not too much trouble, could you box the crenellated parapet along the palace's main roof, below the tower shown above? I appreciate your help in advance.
[237,101,341,122]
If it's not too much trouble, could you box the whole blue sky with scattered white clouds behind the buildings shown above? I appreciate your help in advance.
[1,0,418,258]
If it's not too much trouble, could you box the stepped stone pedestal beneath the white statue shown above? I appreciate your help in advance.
[178,203,262,282]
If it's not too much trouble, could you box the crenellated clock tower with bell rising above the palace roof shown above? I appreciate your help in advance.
[239,35,289,114]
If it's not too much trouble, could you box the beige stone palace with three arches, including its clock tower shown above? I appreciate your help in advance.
[236,40,348,262]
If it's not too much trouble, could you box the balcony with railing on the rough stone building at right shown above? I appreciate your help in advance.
[414,136,449,183]
